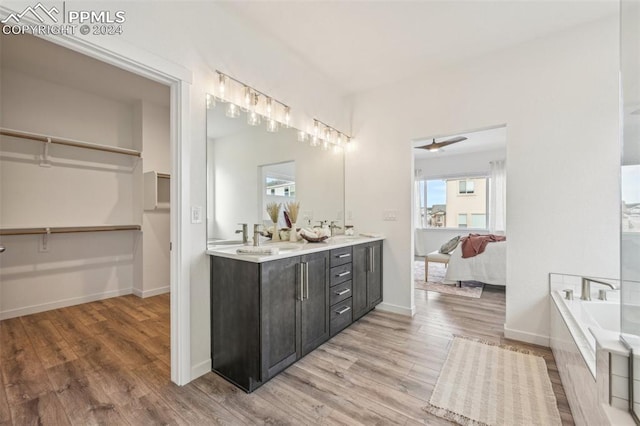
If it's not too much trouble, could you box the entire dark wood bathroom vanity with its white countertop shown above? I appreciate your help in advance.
[207,237,382,392]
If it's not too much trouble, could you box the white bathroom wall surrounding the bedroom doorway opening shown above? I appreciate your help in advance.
[346,17,620,344]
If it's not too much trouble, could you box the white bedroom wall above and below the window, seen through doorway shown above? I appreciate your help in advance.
[414,149,506,256]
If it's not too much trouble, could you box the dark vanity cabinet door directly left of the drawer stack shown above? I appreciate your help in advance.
[300,251,330,356]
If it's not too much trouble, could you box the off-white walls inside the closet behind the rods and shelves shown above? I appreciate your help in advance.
[0,36,169,319]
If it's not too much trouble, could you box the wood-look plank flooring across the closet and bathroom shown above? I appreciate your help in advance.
[0,287,573,425]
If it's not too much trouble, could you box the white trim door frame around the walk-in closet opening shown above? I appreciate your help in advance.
[0,5,192,386]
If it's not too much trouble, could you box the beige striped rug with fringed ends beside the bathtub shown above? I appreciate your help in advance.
[424,337,562,426]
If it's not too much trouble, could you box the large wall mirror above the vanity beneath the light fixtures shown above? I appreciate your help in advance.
[207,95,344,245]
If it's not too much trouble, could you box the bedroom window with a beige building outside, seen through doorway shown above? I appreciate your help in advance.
[416,176,489,229]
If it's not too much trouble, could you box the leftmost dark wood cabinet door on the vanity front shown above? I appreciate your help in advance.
[260,257,302,381]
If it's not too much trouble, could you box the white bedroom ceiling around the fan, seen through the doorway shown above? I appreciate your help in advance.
[413,127,507,160]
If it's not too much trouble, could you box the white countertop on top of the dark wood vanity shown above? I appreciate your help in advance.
[206,235,384,263]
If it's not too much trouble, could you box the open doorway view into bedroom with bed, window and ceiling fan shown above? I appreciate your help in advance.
[412,125,507,303]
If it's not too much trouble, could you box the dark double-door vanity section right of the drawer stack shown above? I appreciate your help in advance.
[353,241,382,321]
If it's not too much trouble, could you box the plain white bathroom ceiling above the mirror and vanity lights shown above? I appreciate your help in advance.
[220,0,618,93]
